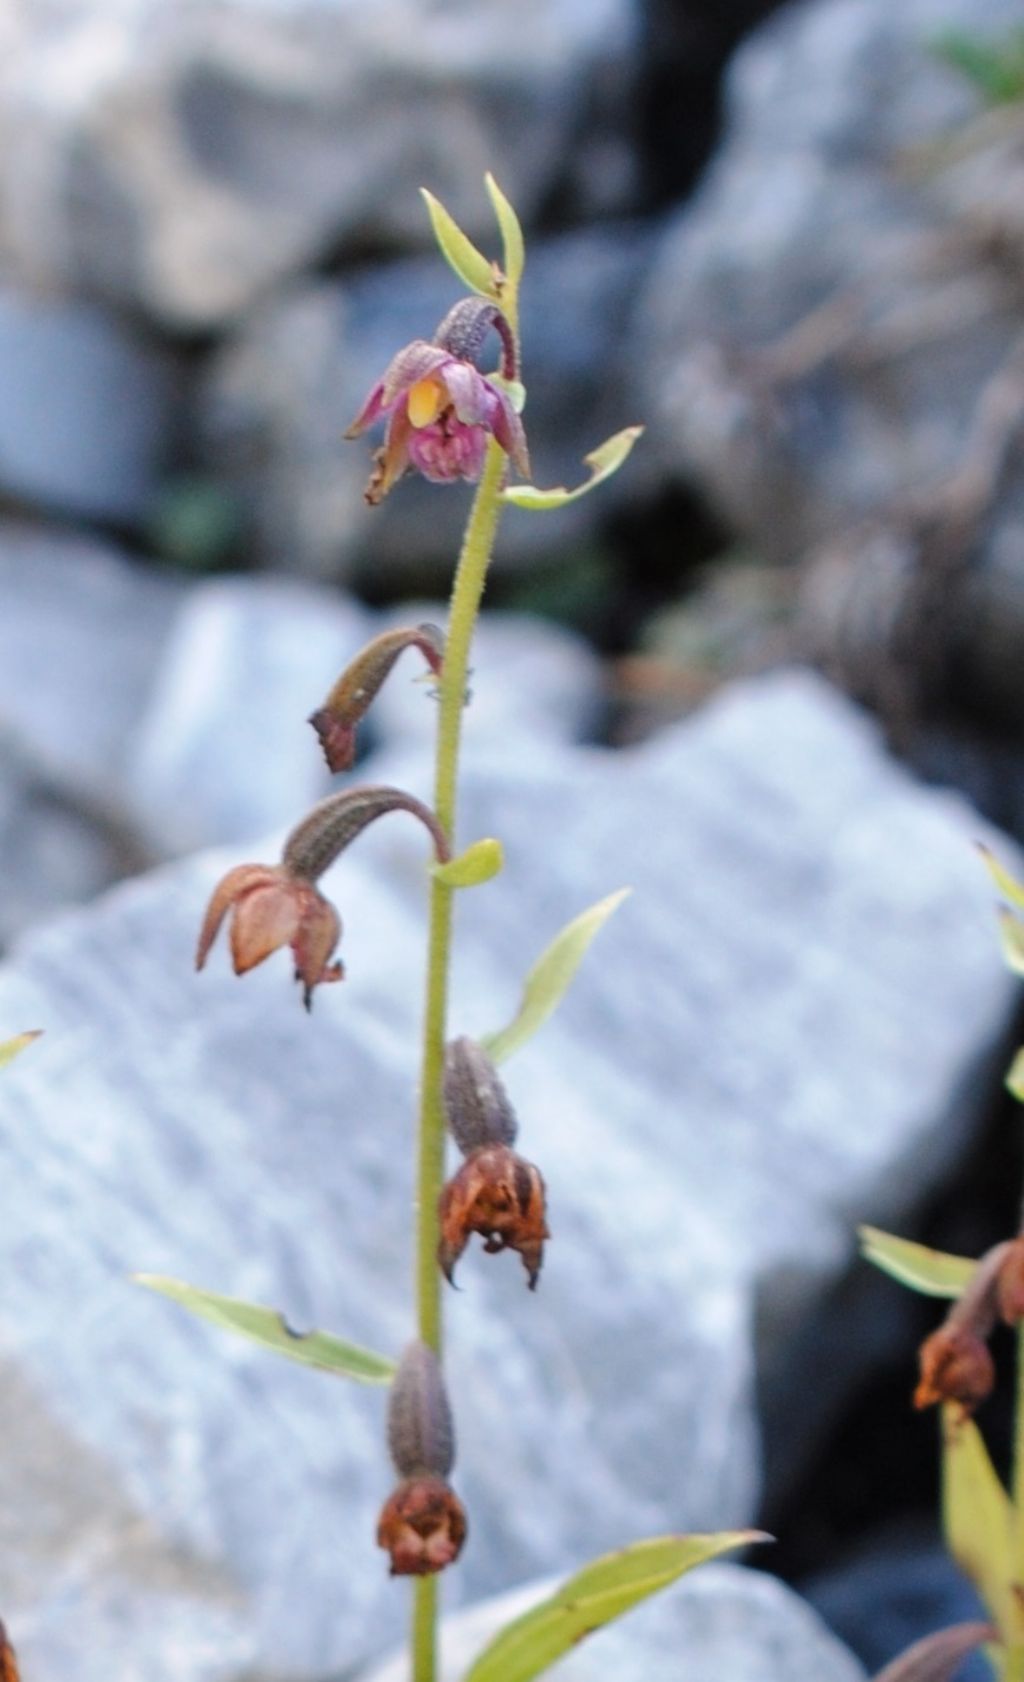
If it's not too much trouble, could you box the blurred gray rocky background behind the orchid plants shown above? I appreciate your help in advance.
[0,0,1024,1682]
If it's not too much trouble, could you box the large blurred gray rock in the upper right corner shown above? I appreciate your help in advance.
[632,0,1024,568]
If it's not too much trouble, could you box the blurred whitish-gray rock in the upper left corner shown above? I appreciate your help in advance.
[0,0,636,330]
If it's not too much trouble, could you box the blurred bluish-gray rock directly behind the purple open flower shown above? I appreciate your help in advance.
[198,224,651,581]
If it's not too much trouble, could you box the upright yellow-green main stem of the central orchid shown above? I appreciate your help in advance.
[412,441,506,1682]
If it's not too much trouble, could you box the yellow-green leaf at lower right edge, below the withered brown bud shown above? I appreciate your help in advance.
[942,1403,1021,1643]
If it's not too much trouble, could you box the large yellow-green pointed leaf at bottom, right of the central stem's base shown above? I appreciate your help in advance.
[464,1531,770,1682]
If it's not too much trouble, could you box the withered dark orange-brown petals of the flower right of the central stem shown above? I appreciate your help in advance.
[437,1145,550,1290]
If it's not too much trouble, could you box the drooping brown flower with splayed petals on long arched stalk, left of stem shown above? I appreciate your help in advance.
[195,787,451,1009]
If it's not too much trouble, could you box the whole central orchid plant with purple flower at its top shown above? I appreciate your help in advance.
[129,177,757,1682]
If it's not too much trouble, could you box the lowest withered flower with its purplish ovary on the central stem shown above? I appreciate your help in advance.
[377,1341,467,1576]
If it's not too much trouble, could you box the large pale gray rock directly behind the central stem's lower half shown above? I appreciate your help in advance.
[0,663,1011,1682]
